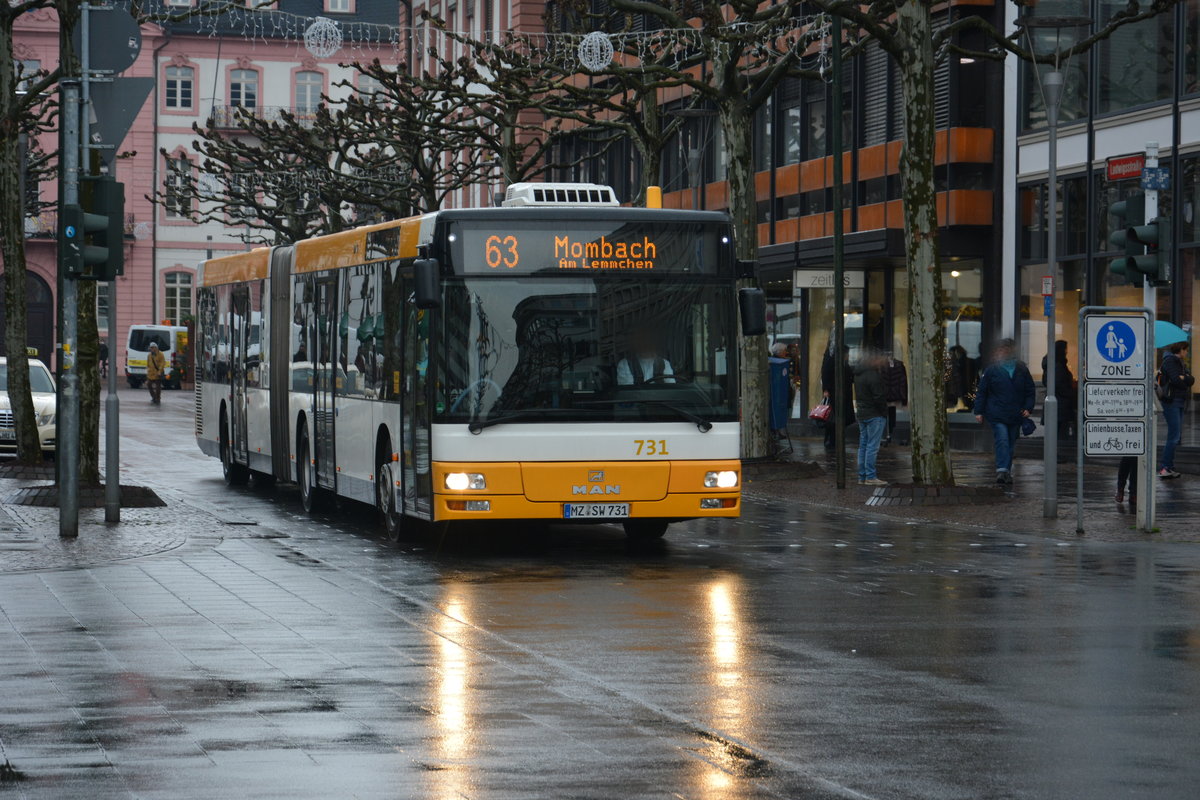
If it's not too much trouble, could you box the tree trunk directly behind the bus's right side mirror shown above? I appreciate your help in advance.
[718,98,770,458]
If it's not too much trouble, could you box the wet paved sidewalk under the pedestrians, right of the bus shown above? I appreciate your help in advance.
[746,431,1200,542]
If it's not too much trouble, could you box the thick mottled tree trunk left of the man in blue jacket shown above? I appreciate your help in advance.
[896,0,954,486]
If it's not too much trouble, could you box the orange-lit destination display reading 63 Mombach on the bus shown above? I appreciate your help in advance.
[450,223,726,275]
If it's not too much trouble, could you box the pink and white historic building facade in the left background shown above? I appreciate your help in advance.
[14,0,406,368]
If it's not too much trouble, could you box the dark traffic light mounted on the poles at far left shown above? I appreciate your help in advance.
[59,175,125,281]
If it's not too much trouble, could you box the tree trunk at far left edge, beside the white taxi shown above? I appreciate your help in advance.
[0,12,46,464]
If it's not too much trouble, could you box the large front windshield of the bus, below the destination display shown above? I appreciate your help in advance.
[436,276,737,425]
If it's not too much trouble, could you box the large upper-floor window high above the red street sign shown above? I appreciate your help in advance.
[1096,0,1175,114]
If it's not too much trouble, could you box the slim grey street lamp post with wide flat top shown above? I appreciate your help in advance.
[1018,13,1092,519]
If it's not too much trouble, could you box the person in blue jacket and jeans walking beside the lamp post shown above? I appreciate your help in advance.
[974,339,1037,486]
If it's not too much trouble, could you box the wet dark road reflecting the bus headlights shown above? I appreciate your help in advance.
[0,392,1200,799]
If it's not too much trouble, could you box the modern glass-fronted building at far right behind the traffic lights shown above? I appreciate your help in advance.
[1002,0,1200,377]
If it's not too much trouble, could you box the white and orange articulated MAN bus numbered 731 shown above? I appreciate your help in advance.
[194,184,761,537]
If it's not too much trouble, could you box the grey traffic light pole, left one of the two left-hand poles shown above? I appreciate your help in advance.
[55,78,83,539]
